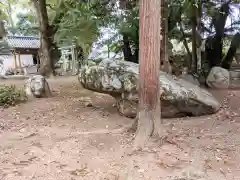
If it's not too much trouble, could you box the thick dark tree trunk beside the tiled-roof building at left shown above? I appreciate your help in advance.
[33,0,56,76]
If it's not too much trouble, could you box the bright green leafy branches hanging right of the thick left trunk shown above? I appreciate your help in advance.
[50,0,110,55]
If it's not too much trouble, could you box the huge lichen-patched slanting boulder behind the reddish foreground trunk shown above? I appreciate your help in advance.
[78,60,220,118]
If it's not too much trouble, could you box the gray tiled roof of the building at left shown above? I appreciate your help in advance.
[5,36,40,49]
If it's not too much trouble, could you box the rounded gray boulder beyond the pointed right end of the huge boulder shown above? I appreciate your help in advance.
[206,66,230,89]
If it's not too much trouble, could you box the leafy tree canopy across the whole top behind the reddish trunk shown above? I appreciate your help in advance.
[0,0,240,74]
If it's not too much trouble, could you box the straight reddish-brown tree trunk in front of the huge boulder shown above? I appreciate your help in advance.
[135,0,161,148]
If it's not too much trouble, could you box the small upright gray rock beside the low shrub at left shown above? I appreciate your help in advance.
[24,75,52,98]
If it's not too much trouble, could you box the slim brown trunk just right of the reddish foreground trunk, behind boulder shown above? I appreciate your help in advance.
[160,0,172,73]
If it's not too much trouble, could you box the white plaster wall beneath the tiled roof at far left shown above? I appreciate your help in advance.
[0,54,33,75]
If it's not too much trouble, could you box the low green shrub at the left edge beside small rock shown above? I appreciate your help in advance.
[0,86,27,107]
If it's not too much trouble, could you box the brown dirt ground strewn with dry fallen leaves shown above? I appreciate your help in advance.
[0,77,240,180]
